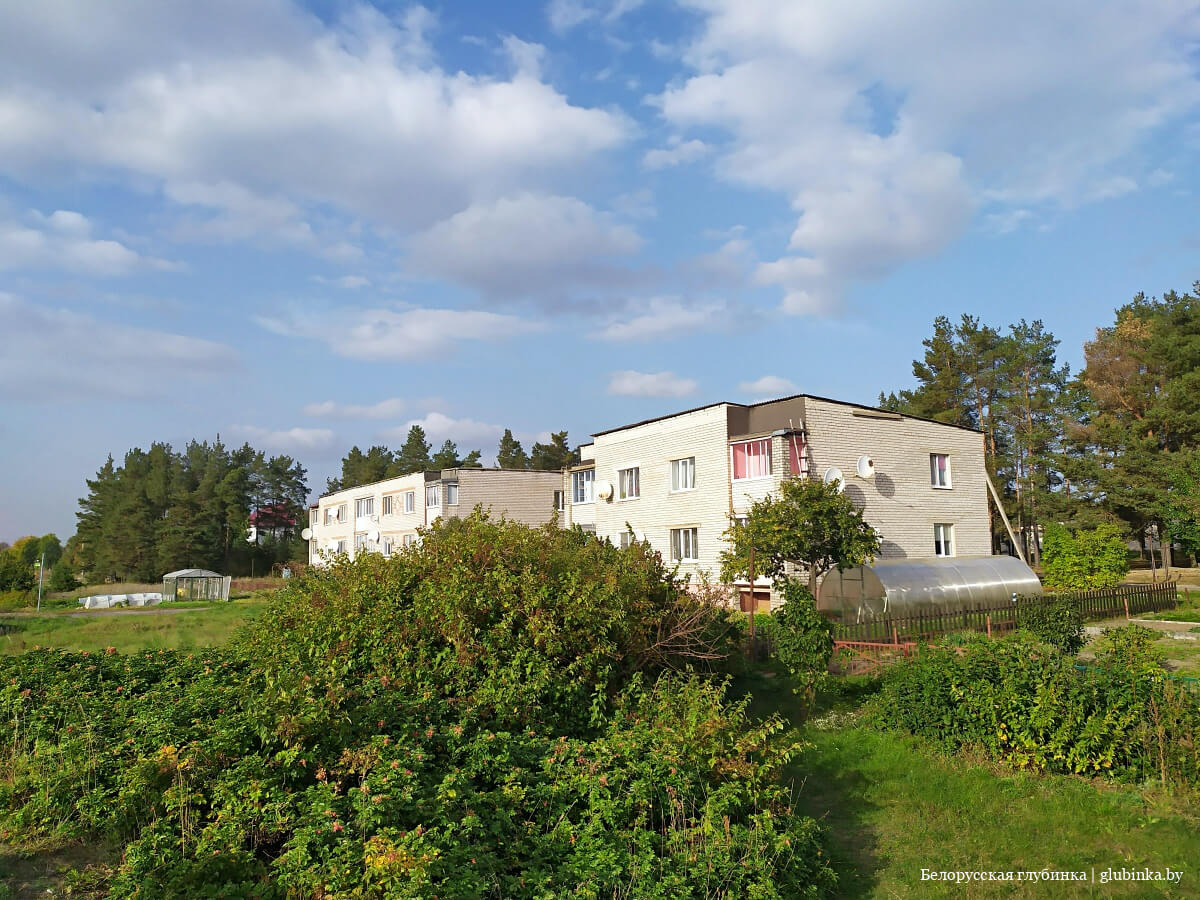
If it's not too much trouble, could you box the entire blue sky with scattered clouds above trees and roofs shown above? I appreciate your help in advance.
[0,0,1200,541]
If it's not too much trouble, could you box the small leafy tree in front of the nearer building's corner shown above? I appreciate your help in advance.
[721,478,880,593]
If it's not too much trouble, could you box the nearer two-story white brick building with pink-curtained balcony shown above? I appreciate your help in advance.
[563,395,991,607]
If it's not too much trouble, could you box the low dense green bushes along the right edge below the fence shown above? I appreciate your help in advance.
[872,629,1200,787]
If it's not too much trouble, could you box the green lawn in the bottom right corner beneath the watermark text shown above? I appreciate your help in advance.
[733,673,1200,898]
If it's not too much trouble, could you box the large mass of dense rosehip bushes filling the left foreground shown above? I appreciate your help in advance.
[0,516,832,898]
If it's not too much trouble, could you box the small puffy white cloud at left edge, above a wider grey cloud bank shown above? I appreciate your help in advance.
[0,210,180,277]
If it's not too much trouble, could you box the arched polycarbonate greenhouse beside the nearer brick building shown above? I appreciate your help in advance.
[817,557,1042,623]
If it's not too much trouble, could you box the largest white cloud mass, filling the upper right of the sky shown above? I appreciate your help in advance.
[653,0,1200,313]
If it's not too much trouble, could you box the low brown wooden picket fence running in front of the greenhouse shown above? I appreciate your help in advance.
[833,582,1178,646]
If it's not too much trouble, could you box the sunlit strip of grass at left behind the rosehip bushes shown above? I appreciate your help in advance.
[0,596,265,654]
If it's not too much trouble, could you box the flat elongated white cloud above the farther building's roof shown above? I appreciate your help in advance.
[256,308,542,360]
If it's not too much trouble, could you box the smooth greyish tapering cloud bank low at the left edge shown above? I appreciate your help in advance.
[0,293,240,401]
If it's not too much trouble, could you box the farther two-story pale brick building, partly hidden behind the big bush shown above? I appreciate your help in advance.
[308,468,563,565]
